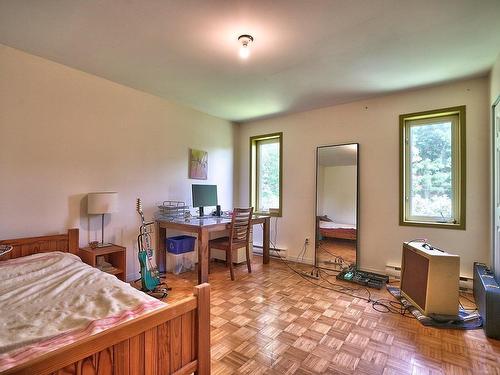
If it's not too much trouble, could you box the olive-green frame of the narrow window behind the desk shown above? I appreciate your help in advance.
[249,132,283,217]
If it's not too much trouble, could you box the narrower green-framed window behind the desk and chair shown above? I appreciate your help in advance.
[250,133,283,216]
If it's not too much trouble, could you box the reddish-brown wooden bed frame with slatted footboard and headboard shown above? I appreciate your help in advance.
[0,229,210,375]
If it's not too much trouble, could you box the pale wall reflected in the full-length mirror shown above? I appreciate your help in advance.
[318,165,356,224]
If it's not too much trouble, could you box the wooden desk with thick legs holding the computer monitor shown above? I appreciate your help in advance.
[156,215,271,284]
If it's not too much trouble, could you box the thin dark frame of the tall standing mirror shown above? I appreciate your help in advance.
[314,142,360,270]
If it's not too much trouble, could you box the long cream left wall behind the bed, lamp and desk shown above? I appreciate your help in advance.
[0,45,234,278]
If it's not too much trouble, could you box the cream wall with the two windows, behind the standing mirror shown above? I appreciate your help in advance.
[238,78,490,275]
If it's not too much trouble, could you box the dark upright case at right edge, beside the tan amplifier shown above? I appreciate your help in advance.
[474,263,500,339]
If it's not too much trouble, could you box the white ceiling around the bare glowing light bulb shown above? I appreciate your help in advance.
[0,0,500,122]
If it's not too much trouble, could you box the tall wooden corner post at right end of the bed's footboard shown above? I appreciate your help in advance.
[194,283,211,375]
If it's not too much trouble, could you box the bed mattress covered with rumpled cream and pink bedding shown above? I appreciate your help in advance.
[0,252,166,372]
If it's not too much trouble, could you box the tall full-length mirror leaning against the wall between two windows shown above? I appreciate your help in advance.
[315,143,359,270]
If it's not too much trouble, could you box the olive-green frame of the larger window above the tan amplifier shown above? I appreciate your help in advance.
[399,106,466,230]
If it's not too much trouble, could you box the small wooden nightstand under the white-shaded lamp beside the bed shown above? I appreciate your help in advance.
[78,244,127,281]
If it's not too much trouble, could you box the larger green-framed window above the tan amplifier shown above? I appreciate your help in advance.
[399,106,465,229]
